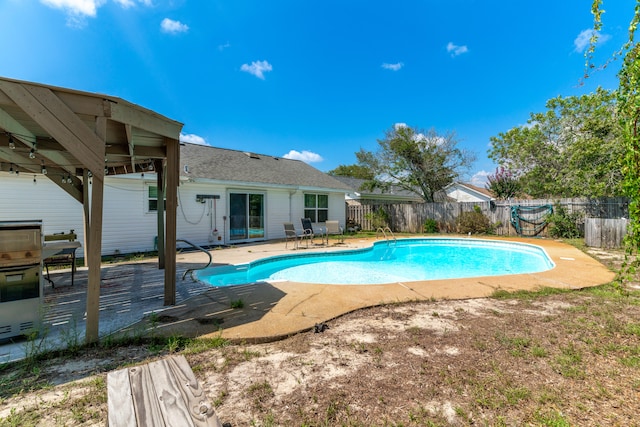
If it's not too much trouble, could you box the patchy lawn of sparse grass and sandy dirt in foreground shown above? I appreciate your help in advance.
[0,246,640,426]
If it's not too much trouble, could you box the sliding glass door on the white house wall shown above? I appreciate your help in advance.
[229,193,264,241]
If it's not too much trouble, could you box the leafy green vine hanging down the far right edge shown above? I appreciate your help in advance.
[585,0,640,279]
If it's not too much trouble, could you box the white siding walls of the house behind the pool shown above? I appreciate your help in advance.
[0,172,345,257]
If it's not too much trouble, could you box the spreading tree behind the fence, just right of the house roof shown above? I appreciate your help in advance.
[356,124,475,202]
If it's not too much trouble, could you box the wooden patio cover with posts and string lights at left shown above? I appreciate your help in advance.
[0,77,183,342]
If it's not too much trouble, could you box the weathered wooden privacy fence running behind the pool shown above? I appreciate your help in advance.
[346,197,628,246]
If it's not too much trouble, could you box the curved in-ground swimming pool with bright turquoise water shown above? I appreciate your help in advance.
[196,238,555,286]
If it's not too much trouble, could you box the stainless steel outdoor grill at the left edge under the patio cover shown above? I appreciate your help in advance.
[0,221,43,340]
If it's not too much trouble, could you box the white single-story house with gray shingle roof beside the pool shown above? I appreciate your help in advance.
[0,144,350,256]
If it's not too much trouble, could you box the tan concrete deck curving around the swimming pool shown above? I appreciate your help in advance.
[136,238,615,342]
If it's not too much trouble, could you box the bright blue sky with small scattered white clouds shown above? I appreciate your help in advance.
[0,0,636,185]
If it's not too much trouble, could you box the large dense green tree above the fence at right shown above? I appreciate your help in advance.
[489,88,623,197]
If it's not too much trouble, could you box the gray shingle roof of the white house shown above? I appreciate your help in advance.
[180,143,349,192]
